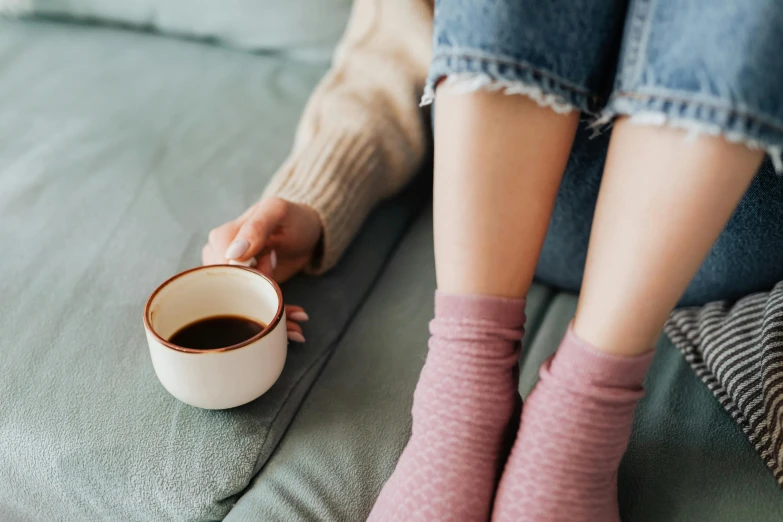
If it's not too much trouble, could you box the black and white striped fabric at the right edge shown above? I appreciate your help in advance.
[666,282,783,486]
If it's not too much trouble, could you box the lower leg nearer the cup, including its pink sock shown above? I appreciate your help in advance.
[370,89,578,522]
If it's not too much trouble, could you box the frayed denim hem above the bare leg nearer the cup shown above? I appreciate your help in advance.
[421,51,599,114]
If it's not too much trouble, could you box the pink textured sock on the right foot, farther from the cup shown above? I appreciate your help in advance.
[492,322,652,522]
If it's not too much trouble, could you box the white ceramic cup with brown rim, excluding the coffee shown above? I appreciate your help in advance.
[144,265,288,410]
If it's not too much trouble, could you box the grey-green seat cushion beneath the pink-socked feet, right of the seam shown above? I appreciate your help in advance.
[226,208,783,522]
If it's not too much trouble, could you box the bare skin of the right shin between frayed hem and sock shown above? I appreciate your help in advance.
[574,121,763,355]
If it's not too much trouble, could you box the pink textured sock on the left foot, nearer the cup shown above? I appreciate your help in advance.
[368,292,525,522]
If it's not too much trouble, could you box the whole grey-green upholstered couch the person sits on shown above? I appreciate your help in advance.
[0,8,783,522]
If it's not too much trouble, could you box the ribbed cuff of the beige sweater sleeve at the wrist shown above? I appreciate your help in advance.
[264,128,382,274]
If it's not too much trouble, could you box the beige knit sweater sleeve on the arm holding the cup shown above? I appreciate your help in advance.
[264,0,432,273]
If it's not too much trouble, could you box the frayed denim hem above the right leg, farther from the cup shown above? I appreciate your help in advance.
[590,93,783,174]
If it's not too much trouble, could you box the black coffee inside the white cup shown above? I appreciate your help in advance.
[169,315,265,350]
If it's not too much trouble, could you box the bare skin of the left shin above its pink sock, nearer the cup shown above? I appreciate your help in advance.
[434,89,579,297]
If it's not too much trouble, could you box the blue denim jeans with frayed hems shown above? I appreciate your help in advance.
[423,0,783,305]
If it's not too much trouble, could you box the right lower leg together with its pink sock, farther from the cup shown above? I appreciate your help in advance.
[493,121,762,522]
